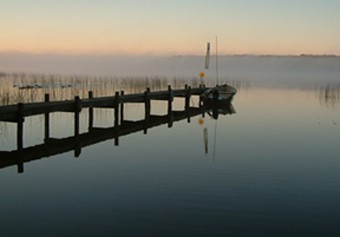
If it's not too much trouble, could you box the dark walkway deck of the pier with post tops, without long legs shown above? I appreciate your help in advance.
[0,86,204,122]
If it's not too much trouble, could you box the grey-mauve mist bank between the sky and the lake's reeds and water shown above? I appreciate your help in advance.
[0,53,340,88]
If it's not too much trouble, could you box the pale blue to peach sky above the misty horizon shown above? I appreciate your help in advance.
[0,0,340,55]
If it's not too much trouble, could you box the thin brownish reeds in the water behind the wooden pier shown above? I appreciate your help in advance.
[0,72,241,105]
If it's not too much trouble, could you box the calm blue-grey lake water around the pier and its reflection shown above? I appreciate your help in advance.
[0,82,340,236]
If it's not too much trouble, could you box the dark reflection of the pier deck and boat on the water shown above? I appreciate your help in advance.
[0,100,235,173]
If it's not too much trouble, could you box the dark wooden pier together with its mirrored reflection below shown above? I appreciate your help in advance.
[0,86,234,173]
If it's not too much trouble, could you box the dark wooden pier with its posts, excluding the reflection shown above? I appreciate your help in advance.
[0,85,205,146]
